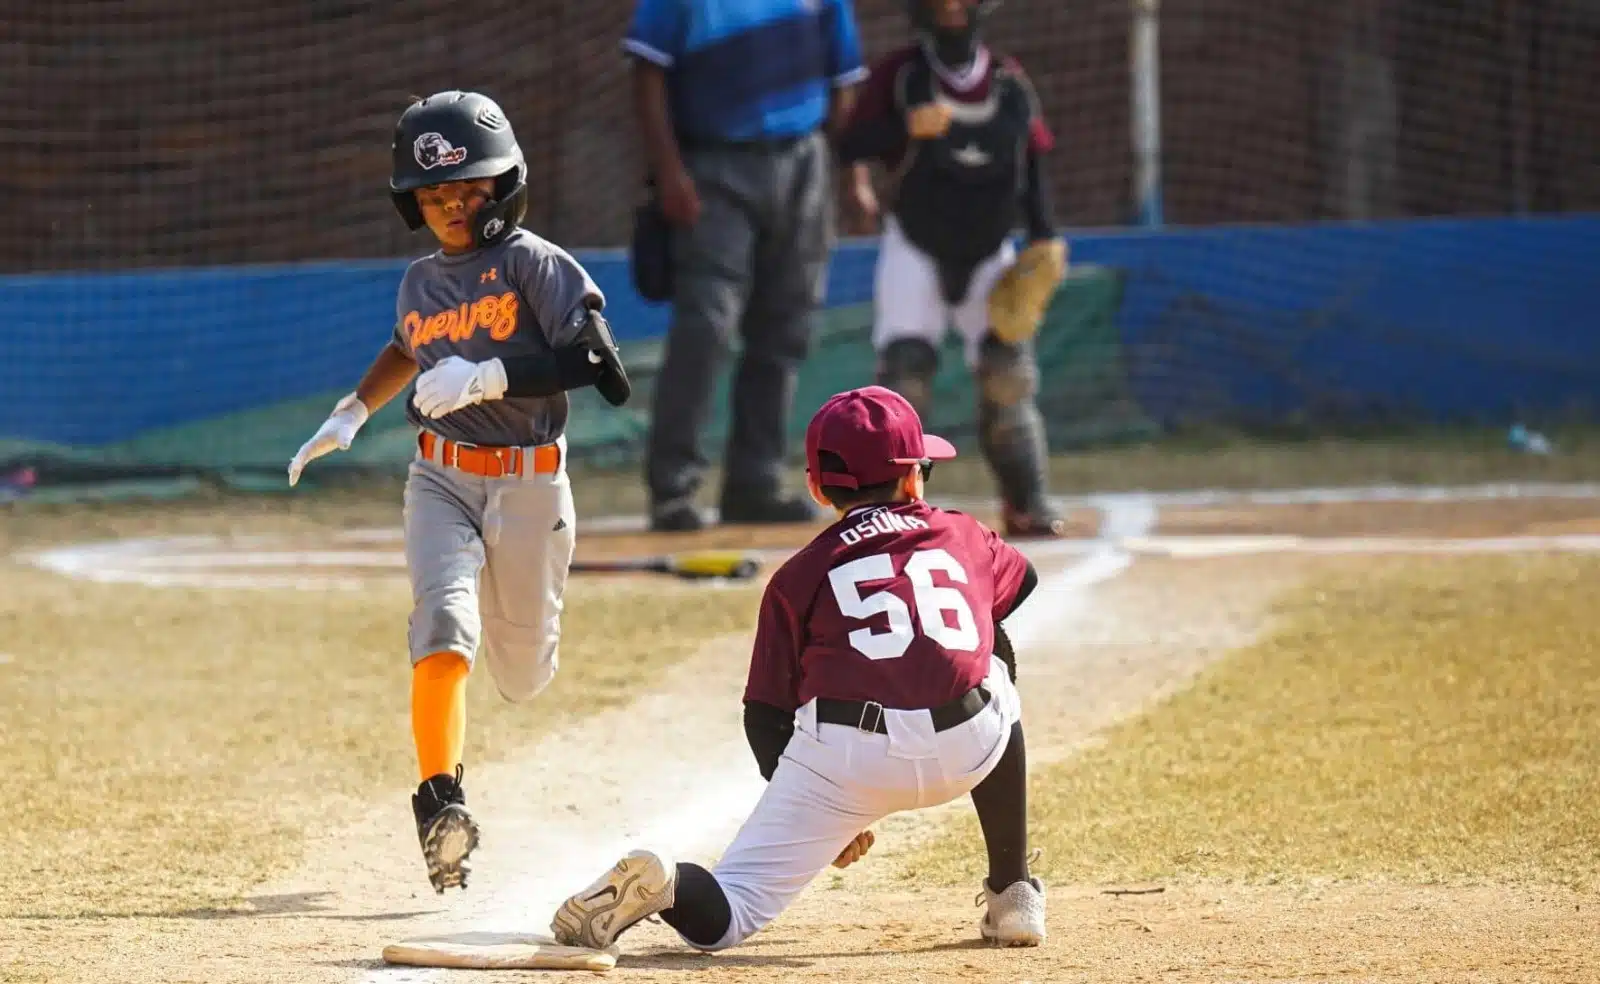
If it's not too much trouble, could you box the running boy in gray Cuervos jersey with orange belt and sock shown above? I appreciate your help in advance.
[288,91,629,893]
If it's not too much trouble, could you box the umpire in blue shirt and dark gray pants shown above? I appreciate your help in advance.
[622,0,866,531]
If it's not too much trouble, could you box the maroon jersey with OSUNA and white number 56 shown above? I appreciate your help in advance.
[744,501,1027,710]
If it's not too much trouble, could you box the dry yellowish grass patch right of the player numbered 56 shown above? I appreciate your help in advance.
[914,557,1600,888]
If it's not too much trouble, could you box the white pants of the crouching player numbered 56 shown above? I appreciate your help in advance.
[685,659,1022,950]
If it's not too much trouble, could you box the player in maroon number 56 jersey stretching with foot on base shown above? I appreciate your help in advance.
[550,386,1045,950]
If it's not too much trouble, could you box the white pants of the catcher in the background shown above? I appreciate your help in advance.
[872,216,1016,365]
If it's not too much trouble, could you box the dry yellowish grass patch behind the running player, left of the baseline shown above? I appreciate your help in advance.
[0,562,760,917]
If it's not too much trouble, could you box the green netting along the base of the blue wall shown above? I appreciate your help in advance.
[0,267,1132,494]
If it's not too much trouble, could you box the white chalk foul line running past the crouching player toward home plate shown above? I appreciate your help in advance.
[363,498,1155,984]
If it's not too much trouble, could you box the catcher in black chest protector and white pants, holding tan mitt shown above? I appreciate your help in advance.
[838,0,1067,536]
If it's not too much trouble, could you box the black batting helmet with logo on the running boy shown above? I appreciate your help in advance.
[389,90,528,246]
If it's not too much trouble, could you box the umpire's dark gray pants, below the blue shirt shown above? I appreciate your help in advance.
[645,133,834,509]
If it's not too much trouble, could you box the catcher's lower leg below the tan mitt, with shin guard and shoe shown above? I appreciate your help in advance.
[978,336,1064,536]
